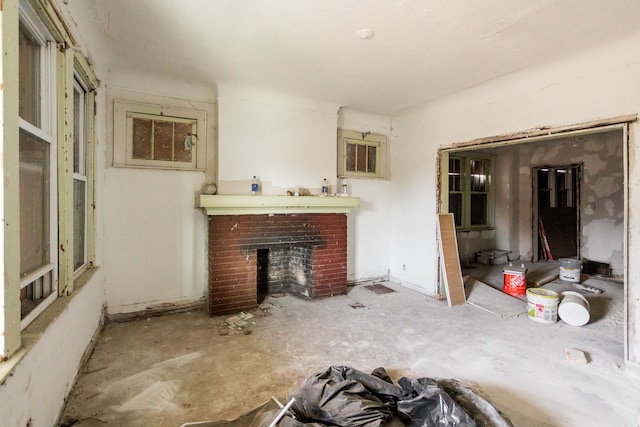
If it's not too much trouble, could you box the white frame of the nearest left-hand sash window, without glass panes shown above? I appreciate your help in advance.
[18,2,59,329]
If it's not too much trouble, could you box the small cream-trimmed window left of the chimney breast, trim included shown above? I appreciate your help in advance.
[114,101,207,170]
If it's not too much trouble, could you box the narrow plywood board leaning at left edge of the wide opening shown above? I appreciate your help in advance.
[438,213,466,307]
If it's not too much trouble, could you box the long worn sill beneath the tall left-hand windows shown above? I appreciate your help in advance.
[0,267,98,385]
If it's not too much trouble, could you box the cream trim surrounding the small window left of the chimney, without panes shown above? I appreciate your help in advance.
[113,100,208,171]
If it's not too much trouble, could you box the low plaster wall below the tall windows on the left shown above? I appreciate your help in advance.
[0,270,104,427]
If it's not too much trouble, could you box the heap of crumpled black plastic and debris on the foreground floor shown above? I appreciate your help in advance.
[183,366,513,427]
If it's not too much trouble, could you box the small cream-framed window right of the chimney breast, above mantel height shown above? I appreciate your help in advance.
[338,130,389,178]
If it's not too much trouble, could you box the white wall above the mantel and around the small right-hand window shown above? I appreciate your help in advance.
[218,86,391,280]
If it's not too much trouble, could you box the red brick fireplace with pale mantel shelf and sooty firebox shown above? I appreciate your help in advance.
[201,196,359,315]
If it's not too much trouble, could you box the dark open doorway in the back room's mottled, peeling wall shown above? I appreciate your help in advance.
[532,164,583,261]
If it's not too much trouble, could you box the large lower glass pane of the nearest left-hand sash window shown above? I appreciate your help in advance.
[19,131,50,277]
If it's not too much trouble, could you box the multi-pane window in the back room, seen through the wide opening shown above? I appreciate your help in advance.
[449,156,491,229]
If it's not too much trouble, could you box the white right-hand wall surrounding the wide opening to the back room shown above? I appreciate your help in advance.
[391,33,640,361]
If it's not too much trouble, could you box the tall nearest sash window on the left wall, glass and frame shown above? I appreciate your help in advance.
[18,4,58,327]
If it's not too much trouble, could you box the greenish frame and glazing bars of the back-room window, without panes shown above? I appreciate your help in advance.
[447,153,494,231]
